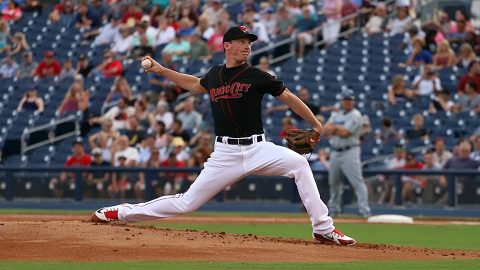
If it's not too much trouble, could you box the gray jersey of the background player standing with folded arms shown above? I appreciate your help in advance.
[327,109,363,148]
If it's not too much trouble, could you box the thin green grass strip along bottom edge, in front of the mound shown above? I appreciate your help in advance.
[0,260,480,270]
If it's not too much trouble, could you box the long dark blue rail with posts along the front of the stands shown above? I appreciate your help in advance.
[0,167,480,207]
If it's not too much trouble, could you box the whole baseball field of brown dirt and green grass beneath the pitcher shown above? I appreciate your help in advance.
[0,209,480,270]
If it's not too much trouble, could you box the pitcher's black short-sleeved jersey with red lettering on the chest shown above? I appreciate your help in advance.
[200,64,286,138]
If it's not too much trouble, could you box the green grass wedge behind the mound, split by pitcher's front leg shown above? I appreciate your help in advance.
[145,223,480,250]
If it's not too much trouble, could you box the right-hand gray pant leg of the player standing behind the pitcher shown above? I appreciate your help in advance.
[342,147,370,215]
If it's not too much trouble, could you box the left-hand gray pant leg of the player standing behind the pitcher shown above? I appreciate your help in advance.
[328,152,343,213]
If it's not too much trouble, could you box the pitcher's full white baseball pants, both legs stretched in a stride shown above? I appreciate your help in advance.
[118,136,335,234]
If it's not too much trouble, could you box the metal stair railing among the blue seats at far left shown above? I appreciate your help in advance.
[21,115,80,154]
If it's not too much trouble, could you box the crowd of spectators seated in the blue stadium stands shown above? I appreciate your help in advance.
[0,0,480,205]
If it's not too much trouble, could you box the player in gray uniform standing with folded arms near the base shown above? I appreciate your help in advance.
[324,90,370,217]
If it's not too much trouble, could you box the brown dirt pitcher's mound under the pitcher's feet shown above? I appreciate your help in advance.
[0,216,480,262]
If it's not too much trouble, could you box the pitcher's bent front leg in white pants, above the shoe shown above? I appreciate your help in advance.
[247,143,335,234]
